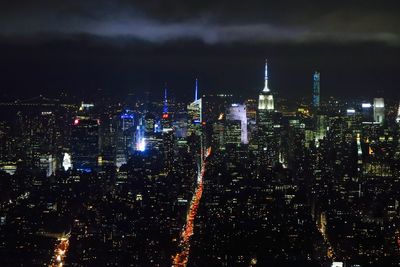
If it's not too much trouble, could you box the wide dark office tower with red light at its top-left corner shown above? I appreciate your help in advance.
[71,118,99,172]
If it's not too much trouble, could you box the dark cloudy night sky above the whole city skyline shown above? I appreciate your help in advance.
[0,0,400,101]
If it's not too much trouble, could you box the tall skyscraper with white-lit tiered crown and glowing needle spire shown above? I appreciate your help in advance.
[257,59,278,166]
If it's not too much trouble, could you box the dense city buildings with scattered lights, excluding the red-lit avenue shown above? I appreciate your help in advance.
[0,59,400,267]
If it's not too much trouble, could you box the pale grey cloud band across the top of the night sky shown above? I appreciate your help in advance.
[0,0,400,45]
